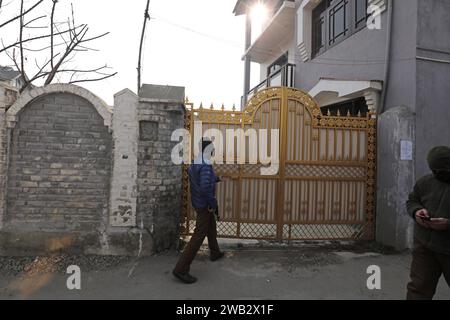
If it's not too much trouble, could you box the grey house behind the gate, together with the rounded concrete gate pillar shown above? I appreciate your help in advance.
[234,0,450,249]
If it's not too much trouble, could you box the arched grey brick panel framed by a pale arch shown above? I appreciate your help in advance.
[6,93,111,231]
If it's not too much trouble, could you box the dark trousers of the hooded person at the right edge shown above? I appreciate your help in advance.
[407,240,450,300]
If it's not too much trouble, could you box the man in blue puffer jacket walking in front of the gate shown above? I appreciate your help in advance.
[173,139,224,284]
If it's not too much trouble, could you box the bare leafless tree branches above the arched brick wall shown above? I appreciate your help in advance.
[0,0,117,91]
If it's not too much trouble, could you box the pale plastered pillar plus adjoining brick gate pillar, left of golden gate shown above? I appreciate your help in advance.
[110,85,185,254]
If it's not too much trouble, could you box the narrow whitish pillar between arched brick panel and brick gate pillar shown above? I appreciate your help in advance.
[110,89,139,227]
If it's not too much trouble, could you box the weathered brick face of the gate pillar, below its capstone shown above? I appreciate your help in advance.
[137,102,184,251]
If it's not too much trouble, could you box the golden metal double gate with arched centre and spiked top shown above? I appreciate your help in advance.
[182,87,376,240]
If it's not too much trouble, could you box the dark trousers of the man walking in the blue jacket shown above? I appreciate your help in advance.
[174,209,220,274]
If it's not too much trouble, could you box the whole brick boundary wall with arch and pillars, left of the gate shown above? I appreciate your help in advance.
[0,84,184,255]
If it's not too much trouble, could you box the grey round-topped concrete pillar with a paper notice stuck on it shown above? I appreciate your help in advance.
[377,107,415,250]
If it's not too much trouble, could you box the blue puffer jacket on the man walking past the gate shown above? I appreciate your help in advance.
[189,157,219,209]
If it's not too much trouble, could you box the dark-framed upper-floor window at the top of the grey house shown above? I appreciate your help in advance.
[312,0,369,58]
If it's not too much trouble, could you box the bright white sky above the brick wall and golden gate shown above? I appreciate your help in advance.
[0,0,259,108]
